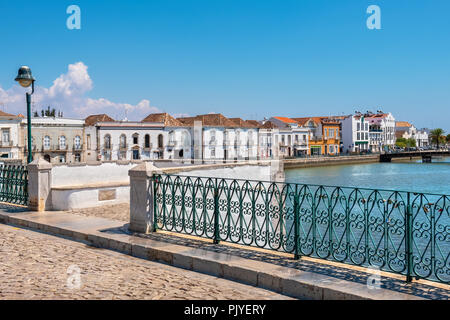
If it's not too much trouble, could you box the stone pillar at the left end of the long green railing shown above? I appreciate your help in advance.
[128,162,161,233]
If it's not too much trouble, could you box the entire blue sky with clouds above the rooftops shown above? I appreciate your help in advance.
[0,0,450,131]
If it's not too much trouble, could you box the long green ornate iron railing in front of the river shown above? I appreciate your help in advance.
[151,174,450,284]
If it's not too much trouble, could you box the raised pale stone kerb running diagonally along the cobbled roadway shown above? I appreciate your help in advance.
[0,211,428,300]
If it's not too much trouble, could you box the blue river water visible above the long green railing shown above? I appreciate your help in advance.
[286,157,450,195]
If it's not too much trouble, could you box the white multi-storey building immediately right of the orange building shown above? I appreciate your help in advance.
[337,114,369,153]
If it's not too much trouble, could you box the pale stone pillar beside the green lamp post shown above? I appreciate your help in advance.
[28,158,52,212]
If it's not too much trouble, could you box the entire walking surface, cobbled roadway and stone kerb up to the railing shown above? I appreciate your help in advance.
[0,205,450,300]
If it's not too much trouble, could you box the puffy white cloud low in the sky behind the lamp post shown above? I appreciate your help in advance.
[0,62,160,120]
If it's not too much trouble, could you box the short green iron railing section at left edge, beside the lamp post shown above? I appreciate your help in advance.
[0,164,28,205]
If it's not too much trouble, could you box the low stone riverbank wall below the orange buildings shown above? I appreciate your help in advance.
[283,155,380,169]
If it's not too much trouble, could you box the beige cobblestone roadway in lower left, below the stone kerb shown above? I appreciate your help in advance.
[0,224,288,300]
